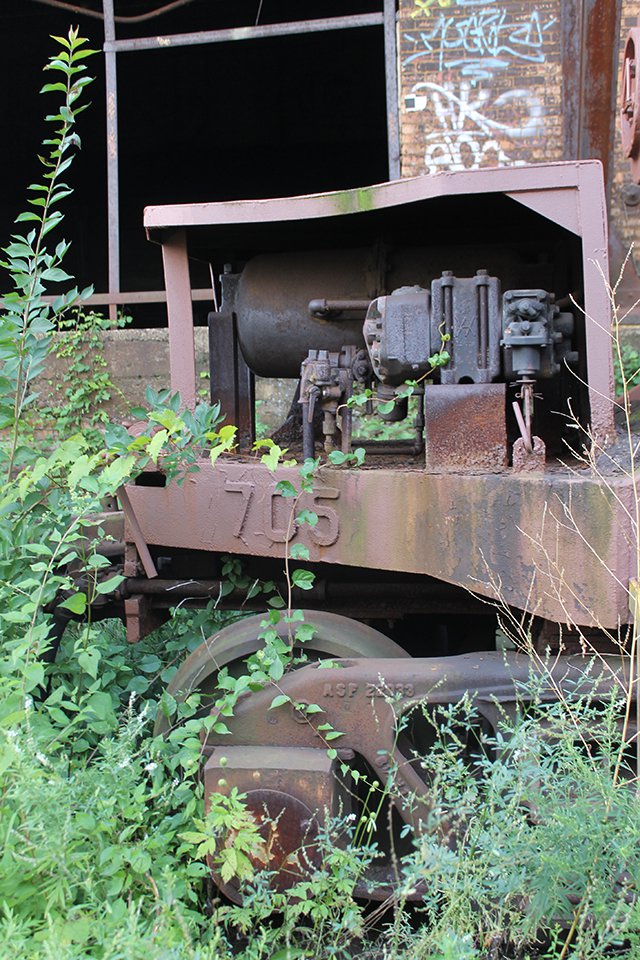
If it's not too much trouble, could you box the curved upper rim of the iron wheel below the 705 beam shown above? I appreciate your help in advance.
[154,610,409,736]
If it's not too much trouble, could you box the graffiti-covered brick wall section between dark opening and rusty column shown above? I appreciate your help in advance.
[399,0,563,176]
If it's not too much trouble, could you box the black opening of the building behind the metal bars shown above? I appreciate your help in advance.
[0,0,388,327]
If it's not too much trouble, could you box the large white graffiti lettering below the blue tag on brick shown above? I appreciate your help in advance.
[405,81,544,173]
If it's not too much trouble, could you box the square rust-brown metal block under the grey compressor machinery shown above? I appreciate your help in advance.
[424,383,507,473]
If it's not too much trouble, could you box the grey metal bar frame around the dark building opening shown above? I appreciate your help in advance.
[100,0,400,319]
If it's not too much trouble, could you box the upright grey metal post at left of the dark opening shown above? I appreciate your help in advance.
[102,0,120,321]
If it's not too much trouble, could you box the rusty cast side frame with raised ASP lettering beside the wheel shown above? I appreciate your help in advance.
[204,652,628,784]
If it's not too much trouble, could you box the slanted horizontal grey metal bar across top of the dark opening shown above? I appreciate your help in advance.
[104,13,384,53]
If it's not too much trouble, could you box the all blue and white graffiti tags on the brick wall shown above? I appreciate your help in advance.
[403,0,557,173]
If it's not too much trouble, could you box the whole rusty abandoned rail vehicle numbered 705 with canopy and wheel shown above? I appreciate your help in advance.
[92,161,637,898]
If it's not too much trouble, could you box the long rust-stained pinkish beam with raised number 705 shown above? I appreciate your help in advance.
[128,458,635,627]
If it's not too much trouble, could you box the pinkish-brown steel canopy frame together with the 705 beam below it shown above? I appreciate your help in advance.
[122,161,631,626]
